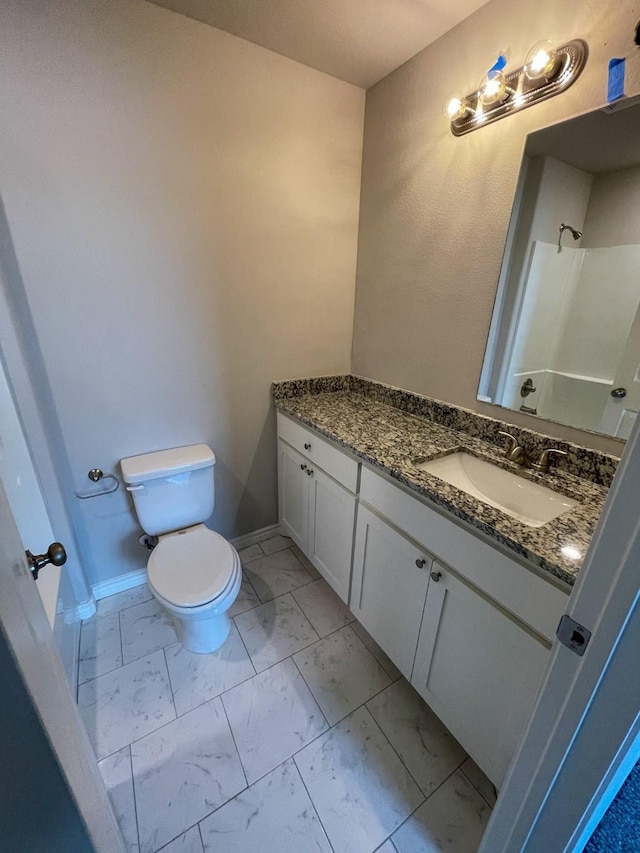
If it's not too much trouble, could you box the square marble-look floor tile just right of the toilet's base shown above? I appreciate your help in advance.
[235,595,319,672]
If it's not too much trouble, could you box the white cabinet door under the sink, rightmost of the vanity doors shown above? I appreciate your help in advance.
[411,562,549,787]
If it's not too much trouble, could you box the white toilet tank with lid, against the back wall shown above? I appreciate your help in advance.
[120,444,216,536]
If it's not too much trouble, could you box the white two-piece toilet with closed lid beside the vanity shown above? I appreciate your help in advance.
[120,444,242,654]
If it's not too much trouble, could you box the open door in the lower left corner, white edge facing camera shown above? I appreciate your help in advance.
[0,476,124,853]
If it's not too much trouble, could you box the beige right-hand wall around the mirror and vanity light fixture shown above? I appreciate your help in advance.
[352,0,640,460]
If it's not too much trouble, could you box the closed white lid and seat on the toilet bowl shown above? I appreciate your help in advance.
[147,524,239,608]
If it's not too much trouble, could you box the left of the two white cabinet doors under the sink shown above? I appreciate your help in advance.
[351,505,431,678]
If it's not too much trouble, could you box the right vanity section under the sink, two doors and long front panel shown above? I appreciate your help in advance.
[351,468,567,786]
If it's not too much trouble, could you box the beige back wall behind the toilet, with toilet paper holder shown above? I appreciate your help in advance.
[0,0,364,582]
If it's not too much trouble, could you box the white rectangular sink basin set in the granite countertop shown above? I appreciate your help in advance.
[414,451,578,527]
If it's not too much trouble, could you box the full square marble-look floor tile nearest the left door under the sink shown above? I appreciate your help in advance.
[293,626,390,724]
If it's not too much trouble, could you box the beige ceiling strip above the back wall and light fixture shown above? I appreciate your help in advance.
[151,0,487,89]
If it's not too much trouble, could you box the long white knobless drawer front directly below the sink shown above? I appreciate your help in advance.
[360,465,567,642]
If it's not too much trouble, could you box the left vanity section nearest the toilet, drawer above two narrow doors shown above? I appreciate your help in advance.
[278,415,358,603]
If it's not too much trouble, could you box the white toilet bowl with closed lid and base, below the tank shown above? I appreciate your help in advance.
[147,524,242,654]
